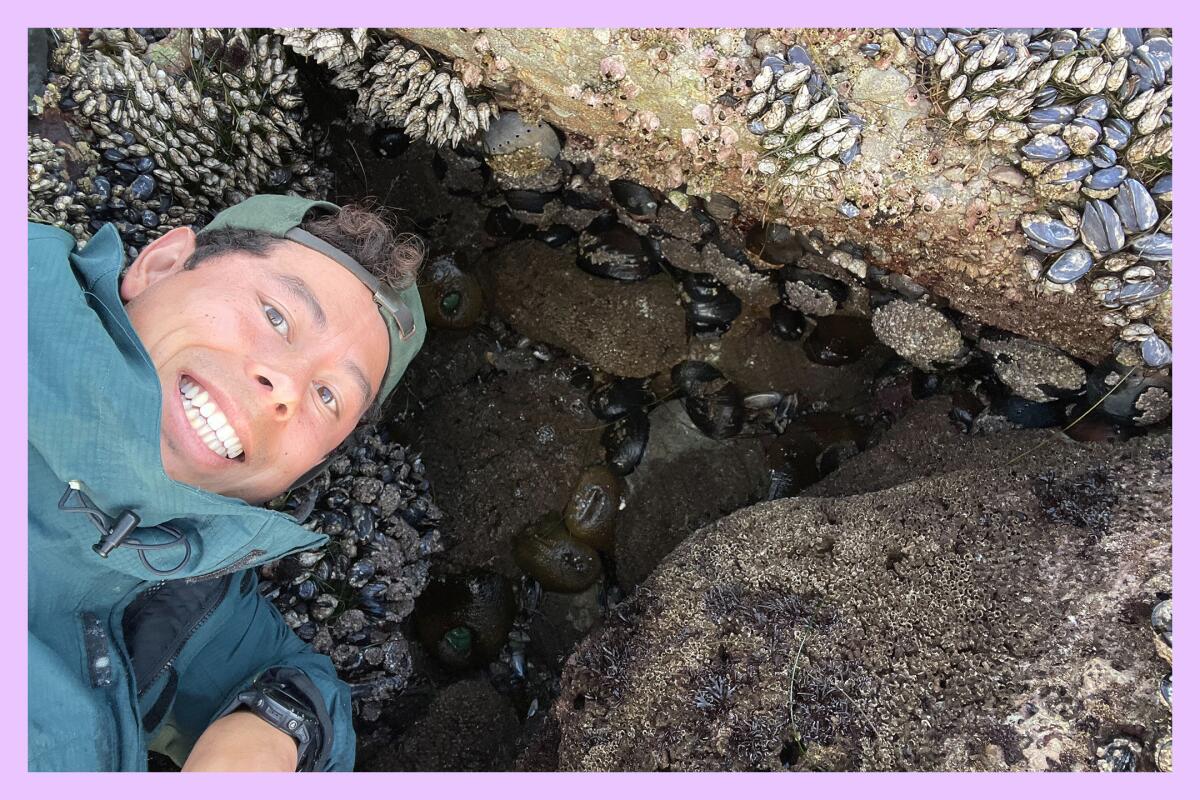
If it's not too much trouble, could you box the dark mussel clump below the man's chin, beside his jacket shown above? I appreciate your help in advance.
[259,425,442,718]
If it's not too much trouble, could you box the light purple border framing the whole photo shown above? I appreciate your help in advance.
[7,0,1200,800]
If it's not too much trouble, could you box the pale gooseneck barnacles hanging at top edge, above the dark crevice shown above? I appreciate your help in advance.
[280,28,499,146]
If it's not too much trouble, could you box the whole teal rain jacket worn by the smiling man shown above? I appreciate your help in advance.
[29,223,354,771]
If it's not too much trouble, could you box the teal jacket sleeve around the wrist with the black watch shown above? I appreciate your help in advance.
[162,570,355,771]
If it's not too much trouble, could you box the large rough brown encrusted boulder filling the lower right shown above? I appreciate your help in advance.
[554,399,1171,770]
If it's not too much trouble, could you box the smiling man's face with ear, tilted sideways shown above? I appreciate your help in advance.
[121,228,389,503]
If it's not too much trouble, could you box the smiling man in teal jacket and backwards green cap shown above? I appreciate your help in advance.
[29,196,425,770]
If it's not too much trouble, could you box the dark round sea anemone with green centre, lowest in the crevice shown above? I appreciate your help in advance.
[413,572,516,669]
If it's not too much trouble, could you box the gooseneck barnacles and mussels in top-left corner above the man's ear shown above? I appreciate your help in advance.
[29,28,325,257]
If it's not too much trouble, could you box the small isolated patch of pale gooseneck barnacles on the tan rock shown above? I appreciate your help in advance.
[745,44,863,186]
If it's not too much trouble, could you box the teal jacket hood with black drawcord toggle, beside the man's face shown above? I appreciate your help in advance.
[29,224,326,579]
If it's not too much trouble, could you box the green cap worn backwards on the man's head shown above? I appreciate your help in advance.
[204,194,426,402]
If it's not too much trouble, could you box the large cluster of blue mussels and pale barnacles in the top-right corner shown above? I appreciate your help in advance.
[898,28,1174,367]
